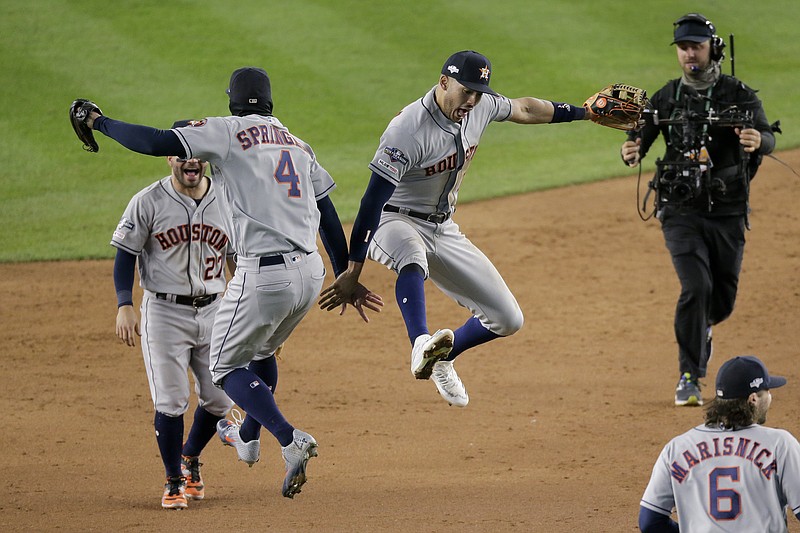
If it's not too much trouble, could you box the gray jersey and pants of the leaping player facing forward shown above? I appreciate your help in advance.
[368,88,523,335]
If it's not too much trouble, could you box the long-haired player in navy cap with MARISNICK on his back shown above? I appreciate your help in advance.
[639,356,800,533]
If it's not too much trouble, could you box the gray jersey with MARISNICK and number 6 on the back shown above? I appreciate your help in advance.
[641,424,800,533]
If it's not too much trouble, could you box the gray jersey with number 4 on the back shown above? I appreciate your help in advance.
[173,115,335,257]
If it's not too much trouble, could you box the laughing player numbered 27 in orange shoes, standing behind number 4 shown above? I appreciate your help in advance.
[111,121,233,509]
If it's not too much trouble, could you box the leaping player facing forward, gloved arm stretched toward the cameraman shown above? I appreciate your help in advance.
[320,50,587,407]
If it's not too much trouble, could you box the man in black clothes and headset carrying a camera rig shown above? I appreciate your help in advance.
[620,13,775,405]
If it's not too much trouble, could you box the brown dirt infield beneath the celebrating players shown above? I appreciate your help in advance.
[0,151,800,532]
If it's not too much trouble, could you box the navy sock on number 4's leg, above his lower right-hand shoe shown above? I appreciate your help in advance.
[222,368,294,446]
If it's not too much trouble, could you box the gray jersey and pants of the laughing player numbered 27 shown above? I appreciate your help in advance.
[111,176,233,416]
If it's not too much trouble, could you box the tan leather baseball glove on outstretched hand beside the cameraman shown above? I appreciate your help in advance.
[583,83,650,131]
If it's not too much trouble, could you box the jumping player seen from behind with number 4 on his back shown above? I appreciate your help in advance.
[86,67,383,498]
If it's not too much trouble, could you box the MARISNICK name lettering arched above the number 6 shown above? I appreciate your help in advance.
[670,437,778,483]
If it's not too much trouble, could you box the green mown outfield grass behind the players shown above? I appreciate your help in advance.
[0,0,800,262]
